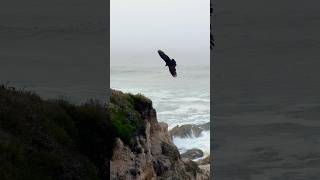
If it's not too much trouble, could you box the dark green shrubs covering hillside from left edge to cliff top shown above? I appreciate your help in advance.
[0,85,151,180]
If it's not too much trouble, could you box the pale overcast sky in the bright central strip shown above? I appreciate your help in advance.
[110,0,210,66]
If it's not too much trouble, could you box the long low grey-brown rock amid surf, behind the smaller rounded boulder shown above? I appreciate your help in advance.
[170,122,210,138]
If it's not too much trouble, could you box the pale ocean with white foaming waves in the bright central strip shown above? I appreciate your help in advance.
[110,65,210,154]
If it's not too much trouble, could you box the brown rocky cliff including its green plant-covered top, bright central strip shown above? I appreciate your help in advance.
[110,91,209,180]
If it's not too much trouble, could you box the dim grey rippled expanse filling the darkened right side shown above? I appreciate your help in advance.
[212,0,320,180]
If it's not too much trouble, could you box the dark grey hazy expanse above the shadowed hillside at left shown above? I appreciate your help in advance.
[0,0,109,102]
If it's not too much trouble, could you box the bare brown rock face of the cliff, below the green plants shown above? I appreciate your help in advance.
[110,91,209,180]
